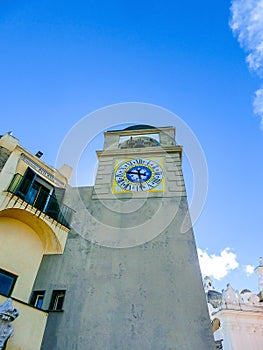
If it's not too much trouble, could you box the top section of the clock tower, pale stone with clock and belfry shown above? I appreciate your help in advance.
[94,125,185,199]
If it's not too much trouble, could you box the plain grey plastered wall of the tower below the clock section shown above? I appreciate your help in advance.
[34,188,214,350]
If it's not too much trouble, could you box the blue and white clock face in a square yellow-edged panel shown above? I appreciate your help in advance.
[114,158,163,193]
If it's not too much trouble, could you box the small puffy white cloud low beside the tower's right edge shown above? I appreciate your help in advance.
[197,248,239,280]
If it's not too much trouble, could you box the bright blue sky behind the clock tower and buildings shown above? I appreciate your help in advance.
[0,0,263,292]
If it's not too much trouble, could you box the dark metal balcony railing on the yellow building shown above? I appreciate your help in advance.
[4,174,74,228]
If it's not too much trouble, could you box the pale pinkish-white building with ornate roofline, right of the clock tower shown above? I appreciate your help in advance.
[204,258,263,350]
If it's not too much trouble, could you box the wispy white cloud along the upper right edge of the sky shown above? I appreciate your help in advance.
[230,0,263,129]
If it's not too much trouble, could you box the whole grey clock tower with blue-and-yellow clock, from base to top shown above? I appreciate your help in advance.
[34,125,214,350]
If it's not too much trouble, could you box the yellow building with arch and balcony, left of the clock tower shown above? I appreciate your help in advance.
[0,133,72,350]
